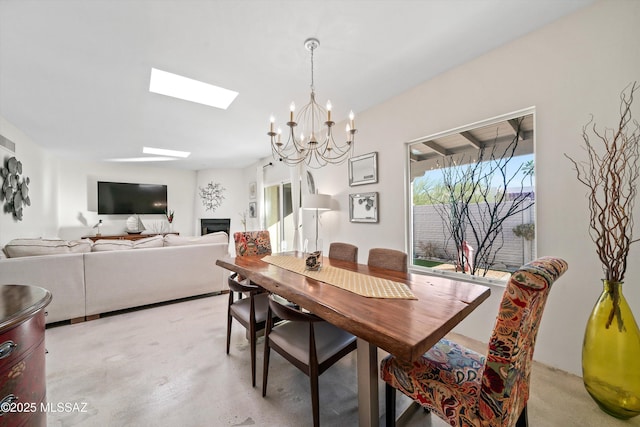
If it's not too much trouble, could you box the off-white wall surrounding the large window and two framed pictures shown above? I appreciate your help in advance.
[296,1,640,375]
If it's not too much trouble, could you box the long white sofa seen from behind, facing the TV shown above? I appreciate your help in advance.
[0,233,229,323]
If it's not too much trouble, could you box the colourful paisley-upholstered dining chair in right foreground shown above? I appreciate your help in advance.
[380,257,568,427]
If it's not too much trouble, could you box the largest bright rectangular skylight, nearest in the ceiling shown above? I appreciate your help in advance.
[149,68,238,110]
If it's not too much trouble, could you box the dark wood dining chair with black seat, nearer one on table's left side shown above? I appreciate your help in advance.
[262,296,356,427]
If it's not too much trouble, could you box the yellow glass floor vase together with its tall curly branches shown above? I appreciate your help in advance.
[565,82,640,419]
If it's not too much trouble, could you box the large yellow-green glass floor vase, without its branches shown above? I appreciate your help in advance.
[582,280,640,419]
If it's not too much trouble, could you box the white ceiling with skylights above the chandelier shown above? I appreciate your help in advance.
[0,0,594,170]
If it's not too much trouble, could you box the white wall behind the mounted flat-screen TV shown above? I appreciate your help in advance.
[0,117,199,245]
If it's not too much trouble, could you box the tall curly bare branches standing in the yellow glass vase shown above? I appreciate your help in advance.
[565,82,640,282]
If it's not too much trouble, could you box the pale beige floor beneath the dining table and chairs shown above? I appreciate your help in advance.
[46,295,640,427]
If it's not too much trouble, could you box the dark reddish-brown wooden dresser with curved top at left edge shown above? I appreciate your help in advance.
[0,285,51,427]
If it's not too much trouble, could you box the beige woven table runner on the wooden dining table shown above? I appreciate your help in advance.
[262,255,417,299]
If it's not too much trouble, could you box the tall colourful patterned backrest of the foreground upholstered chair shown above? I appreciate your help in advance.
[478,257,568,426]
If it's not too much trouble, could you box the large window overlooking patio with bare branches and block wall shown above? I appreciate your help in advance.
[407,109,535,281]
